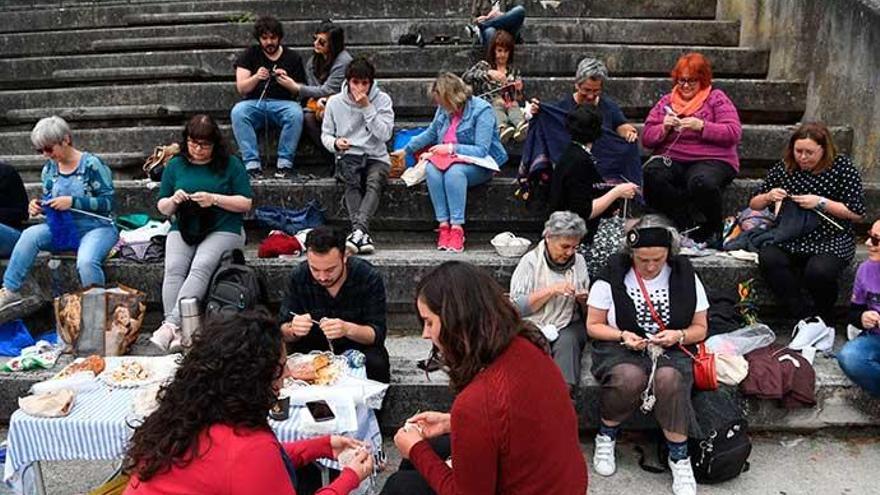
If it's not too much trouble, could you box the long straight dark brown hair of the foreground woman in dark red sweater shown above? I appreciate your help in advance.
[416,261,550,392]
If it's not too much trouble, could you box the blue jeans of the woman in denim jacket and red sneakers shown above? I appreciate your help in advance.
[427,162,495,225]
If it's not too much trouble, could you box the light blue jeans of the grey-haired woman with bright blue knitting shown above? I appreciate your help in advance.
[3,223,119,292]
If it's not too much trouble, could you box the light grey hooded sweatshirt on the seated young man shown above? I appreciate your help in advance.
[321,81,394,164]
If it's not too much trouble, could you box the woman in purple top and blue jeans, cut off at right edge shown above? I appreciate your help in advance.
[837,220,880,397]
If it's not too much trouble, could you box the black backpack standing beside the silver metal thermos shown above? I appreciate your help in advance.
[205,249,265,317]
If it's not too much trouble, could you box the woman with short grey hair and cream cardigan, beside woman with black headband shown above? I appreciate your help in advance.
[510,211,590,397]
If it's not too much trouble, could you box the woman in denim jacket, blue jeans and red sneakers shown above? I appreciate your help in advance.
[393,72,507,253]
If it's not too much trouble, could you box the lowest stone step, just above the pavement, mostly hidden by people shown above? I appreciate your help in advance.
[0,335,880,432]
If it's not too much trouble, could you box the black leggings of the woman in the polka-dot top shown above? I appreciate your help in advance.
[758,245,847,325]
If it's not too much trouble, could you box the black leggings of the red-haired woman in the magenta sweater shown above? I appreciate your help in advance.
[643,157,736,242]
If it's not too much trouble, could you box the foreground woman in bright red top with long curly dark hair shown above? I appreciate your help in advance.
[124,311,373,495]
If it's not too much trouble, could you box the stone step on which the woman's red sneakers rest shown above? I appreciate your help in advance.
[2,221,865,314]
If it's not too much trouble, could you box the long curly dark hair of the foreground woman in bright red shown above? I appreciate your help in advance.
[123,309,282,481]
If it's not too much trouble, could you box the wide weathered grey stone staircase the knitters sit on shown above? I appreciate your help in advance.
[0,0,880,430]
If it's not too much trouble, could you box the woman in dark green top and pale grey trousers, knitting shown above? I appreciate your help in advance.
[150,114,253,351]
